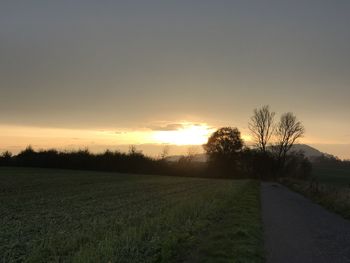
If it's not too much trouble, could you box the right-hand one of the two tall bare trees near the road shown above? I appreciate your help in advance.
[275,112,305,165]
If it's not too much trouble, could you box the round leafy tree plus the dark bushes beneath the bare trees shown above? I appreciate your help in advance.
[204,127,312,180]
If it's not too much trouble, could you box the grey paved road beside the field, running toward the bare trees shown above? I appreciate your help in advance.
[261,183,350,263]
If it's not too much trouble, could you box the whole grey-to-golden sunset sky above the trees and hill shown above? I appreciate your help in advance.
[0,0,350,159]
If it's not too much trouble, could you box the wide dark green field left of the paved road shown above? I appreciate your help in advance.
[0,168,264,262]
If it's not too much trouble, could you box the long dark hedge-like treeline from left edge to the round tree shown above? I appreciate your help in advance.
[0,146,211,177]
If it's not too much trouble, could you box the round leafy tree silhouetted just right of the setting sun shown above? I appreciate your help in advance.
[203,127,243,163]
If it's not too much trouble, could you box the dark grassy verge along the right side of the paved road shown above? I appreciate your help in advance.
[282,179,350,220]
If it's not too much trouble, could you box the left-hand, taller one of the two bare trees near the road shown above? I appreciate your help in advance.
[248,105,275,153]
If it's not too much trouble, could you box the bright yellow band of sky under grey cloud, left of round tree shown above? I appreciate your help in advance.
[0,124,258,155]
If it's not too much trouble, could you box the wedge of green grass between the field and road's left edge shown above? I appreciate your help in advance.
[183,183,263,263]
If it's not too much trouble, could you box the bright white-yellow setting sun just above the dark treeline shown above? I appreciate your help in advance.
[154,124,213,145]
